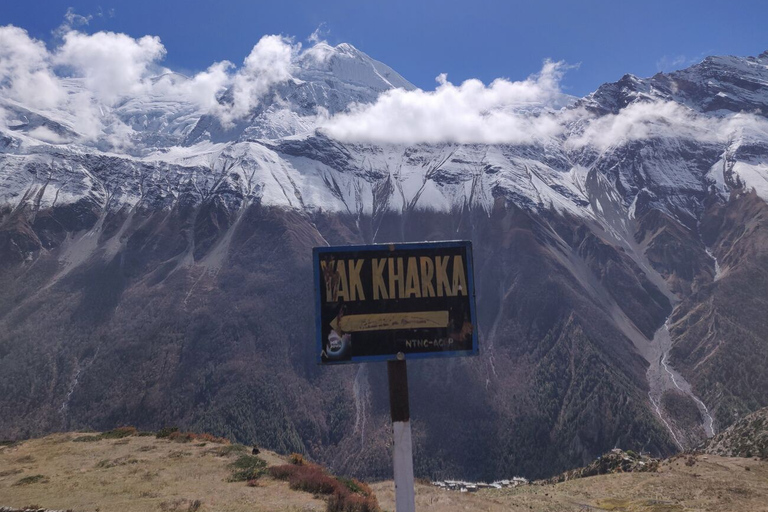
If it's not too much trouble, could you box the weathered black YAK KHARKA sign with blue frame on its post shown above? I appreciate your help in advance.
[313,241,478,512]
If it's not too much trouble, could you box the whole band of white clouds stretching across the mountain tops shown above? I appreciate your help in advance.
[0,19,768,158]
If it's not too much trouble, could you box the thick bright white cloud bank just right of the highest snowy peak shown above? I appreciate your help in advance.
[321,61,564,144]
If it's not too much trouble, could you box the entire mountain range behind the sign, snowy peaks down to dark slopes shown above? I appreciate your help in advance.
[0,39,768,480]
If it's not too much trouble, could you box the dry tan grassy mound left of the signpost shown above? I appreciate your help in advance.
[0,433,326,512]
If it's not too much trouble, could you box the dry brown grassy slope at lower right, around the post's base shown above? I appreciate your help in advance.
[373,456,768,512]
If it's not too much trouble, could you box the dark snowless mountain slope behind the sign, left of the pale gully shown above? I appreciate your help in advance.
[0,192,673,478]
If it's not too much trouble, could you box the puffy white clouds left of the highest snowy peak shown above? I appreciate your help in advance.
[0,22,301,147]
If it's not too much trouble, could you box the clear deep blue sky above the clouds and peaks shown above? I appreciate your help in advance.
[0,0,768,95]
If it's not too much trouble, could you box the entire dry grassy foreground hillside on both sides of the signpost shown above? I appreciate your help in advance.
[0,433,768,512]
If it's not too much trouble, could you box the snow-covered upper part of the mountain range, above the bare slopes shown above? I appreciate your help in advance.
[0,43,768,220]
